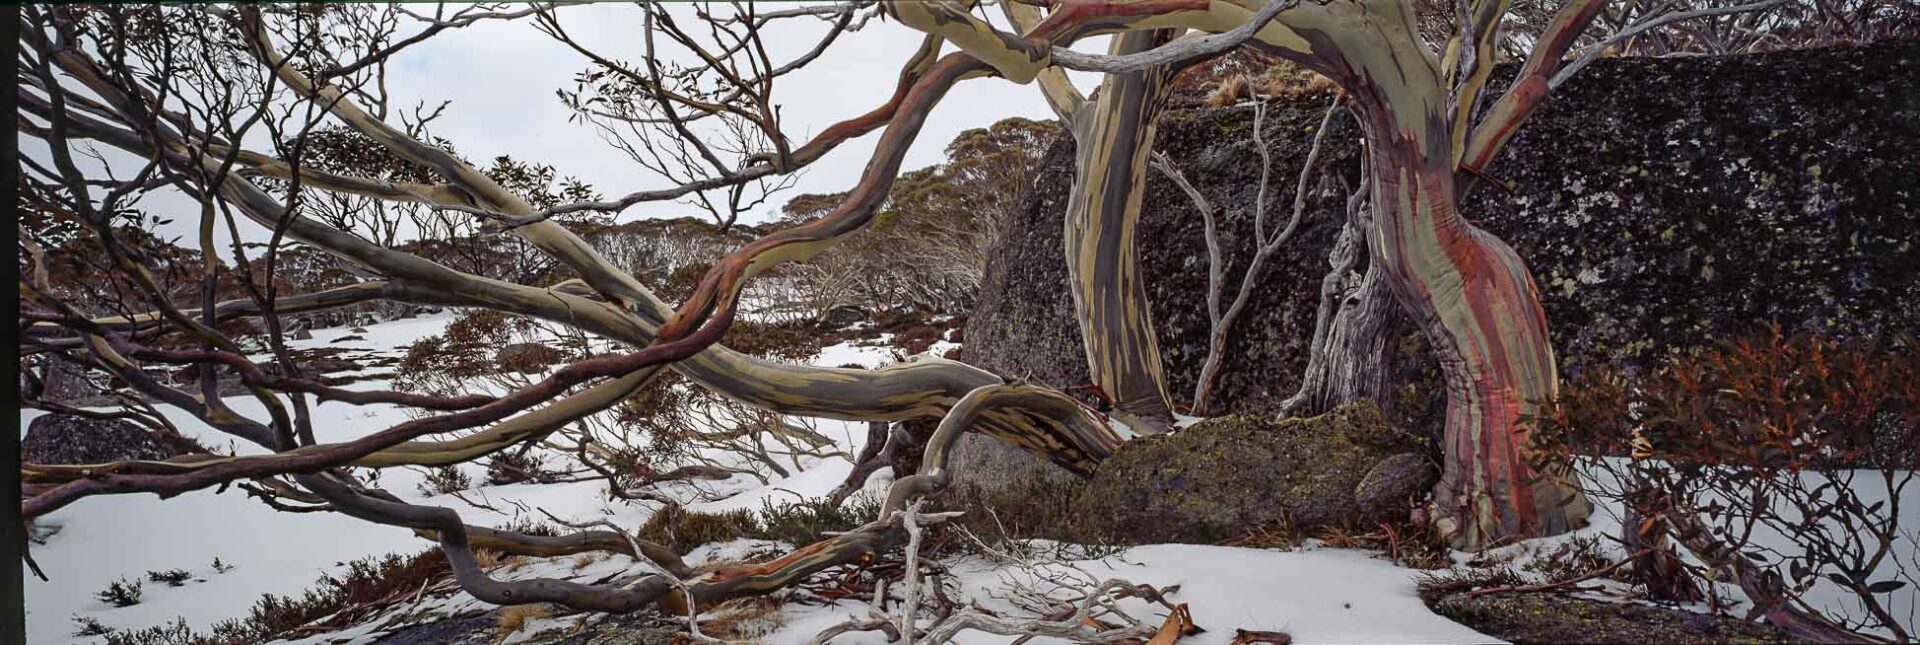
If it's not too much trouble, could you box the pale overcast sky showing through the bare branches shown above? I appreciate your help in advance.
[45,2,1104,247]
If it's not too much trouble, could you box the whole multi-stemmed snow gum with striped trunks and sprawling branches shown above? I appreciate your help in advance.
[17,0,1781,625]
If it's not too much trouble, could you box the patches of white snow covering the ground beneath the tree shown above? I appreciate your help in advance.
[21,315,1920,643]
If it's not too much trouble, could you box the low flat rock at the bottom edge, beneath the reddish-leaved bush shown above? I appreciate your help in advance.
[1432,593,1793,645]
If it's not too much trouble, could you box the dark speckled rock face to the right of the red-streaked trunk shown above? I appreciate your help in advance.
[1467,42,1920,372]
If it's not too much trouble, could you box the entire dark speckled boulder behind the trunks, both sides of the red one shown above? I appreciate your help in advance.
[954,42,1920,484]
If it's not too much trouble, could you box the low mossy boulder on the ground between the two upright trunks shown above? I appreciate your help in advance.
[1075,401,1430,543]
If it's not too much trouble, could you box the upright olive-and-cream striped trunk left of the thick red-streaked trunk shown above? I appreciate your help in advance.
[1066,29,1173,434]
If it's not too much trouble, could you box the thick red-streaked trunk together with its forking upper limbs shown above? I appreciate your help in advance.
[1228,0,1597,549]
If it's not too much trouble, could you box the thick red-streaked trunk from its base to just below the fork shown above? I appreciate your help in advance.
[1367,137,1590,549]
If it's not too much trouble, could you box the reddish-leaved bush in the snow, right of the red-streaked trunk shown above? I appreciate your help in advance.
[1528,328,1920,639]
